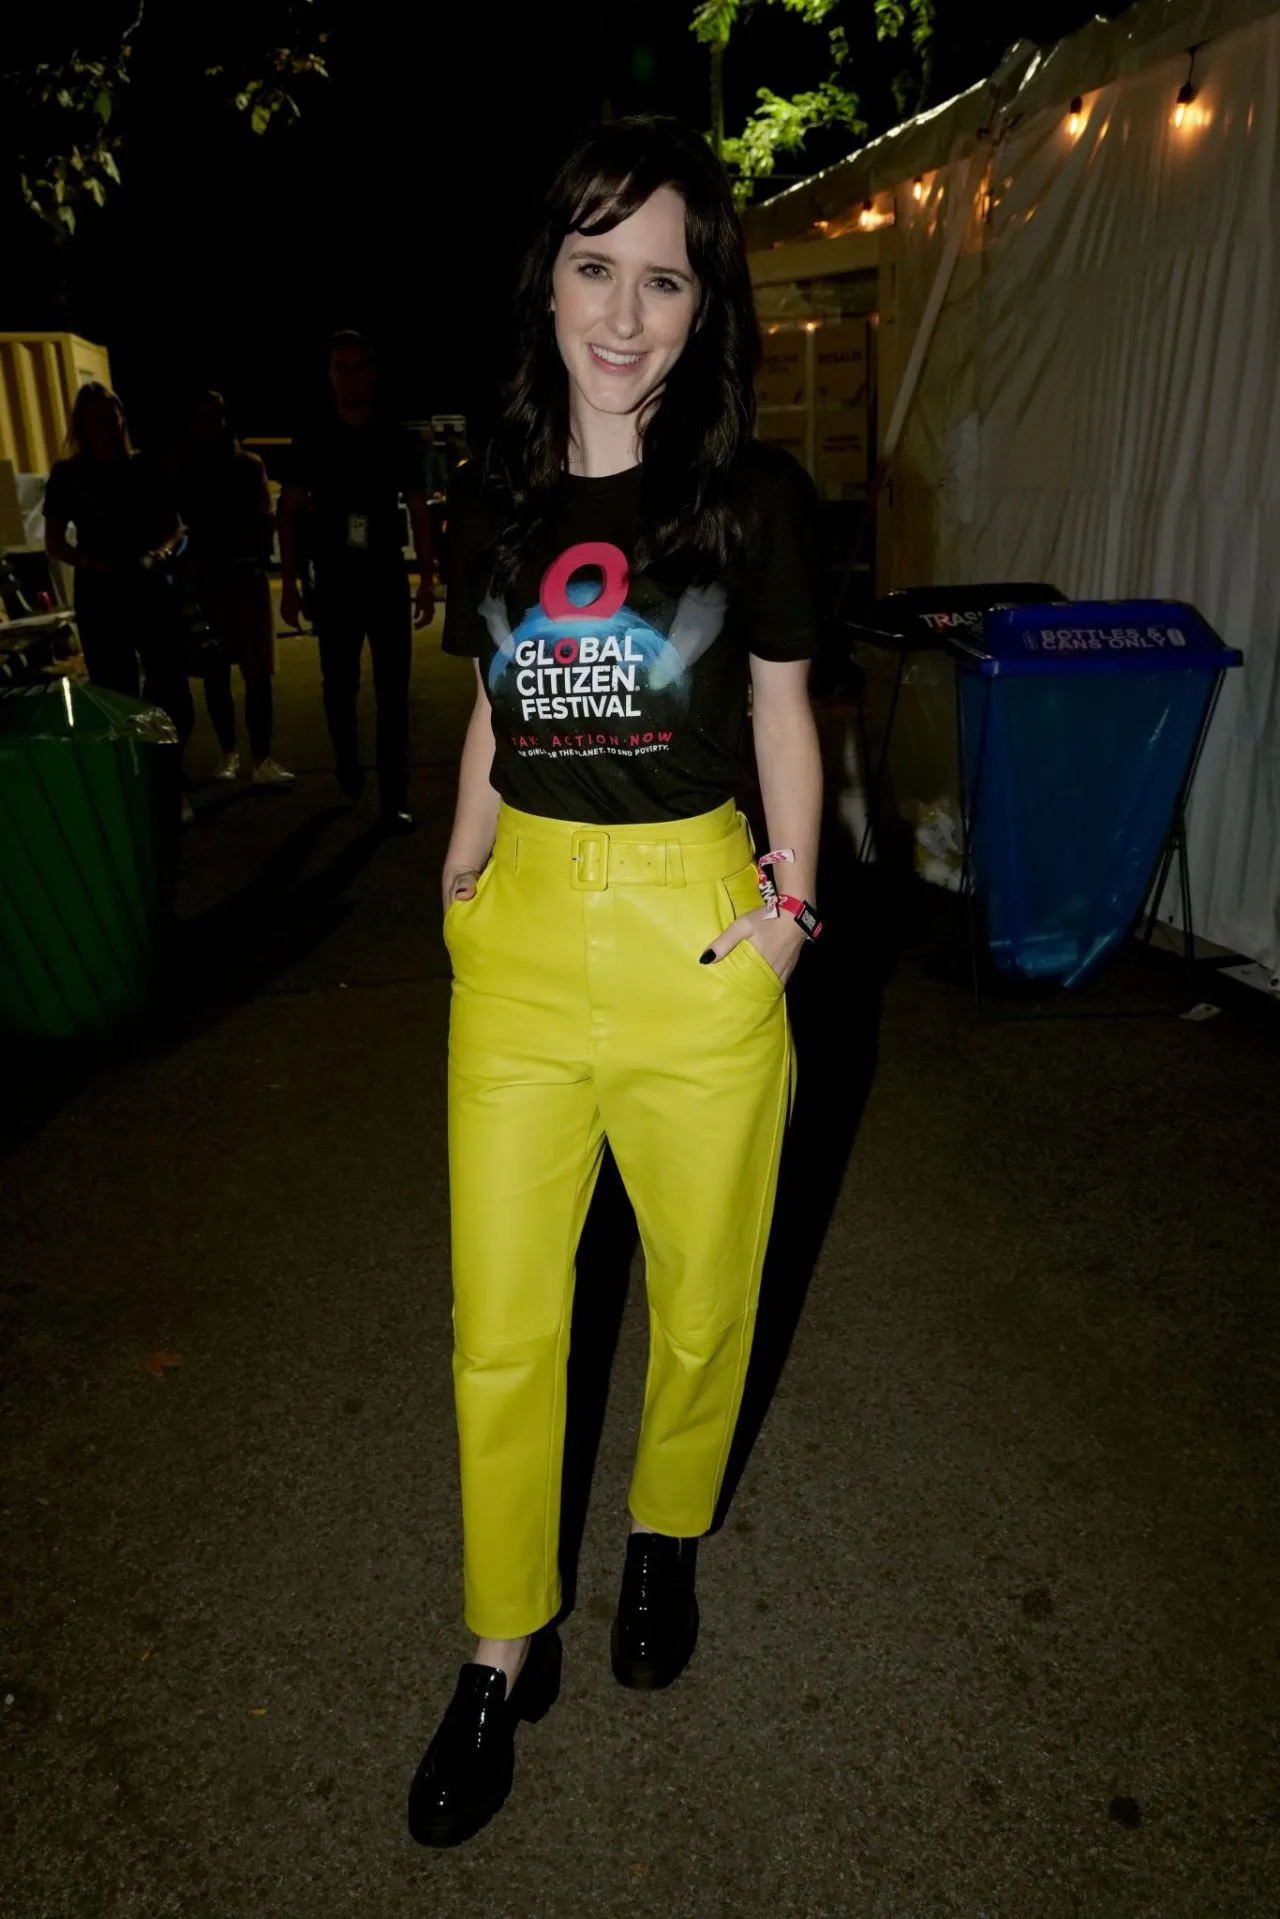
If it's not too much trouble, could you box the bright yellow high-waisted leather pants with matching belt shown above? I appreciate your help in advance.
[445,804,793,1639]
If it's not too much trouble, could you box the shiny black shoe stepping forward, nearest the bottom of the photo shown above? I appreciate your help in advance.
[409,1625,562,1846]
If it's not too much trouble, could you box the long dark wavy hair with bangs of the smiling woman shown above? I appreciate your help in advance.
[487,115,760,589]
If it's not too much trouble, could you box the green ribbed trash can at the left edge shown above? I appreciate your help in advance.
[0,679,180,1042]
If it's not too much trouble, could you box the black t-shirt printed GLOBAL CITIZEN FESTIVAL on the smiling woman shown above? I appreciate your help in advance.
[443,443,818,825]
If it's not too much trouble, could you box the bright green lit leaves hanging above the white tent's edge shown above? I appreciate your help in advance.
[691,0,935,201]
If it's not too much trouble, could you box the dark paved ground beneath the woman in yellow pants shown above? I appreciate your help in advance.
[0,617,1280,1919]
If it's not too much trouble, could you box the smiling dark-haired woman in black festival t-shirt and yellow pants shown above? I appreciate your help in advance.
[409,119,821,1846]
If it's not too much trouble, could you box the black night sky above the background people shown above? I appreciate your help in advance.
[0,0,1096,450]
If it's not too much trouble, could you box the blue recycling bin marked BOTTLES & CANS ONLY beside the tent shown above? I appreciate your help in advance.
[952,601,1242,986]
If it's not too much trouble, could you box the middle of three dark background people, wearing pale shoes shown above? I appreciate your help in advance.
[173,391,294,787]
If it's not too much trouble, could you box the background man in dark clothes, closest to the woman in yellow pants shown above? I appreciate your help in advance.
[280,332,436,833]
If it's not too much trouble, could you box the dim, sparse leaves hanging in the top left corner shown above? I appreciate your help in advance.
[0,0,328,238]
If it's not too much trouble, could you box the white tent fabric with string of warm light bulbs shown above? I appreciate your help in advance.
[750,0,1280,971]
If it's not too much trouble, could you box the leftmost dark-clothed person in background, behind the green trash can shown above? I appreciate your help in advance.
[44,382,196,821]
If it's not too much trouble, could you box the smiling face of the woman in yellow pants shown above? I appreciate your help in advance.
[551,186,699,435]
